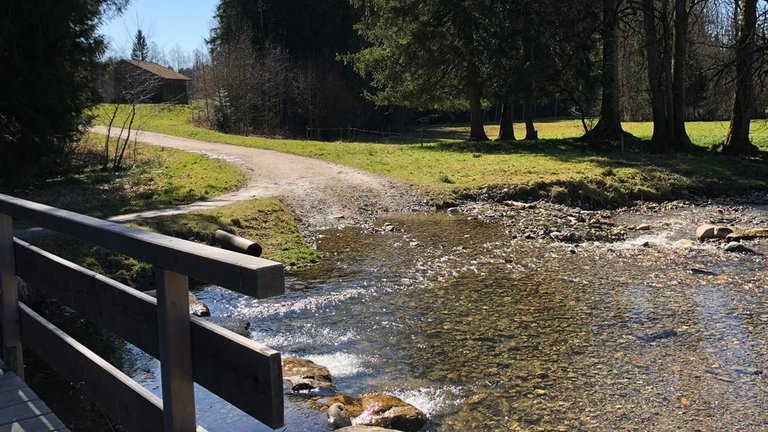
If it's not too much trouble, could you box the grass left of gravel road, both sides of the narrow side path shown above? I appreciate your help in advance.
[18,134,320,289]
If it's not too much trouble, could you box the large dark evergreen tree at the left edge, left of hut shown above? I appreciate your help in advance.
[0,0,127,184]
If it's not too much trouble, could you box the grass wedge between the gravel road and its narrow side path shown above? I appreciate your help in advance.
[19,134,246,218]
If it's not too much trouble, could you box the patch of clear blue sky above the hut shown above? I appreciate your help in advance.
[100,0,218,61]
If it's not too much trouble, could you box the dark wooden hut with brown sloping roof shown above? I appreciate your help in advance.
[101,60,192,104]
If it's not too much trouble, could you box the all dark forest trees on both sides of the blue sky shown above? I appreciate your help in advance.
[0,0,768,186]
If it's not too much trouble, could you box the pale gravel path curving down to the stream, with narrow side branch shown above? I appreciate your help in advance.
[91,126,426,233]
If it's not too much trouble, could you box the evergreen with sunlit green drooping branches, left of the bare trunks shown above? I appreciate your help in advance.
[348,0,491,141]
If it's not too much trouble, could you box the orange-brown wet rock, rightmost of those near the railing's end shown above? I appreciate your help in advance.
[355,394,427,432]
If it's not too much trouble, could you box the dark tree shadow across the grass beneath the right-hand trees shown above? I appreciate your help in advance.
[418,139,768,207]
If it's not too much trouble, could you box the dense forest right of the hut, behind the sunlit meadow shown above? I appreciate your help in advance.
[196,0,768,153]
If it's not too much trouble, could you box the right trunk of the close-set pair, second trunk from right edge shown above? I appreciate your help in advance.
[672,0,693,150]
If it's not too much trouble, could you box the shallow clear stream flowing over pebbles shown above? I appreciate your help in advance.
[120,207,768,431]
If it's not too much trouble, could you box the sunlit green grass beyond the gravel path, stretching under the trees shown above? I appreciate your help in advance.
[93,105,768,206]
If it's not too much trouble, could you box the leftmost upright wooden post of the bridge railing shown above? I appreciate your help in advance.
[0,214,24,380]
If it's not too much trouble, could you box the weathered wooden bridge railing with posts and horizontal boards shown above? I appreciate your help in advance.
[0,194,285,431]
